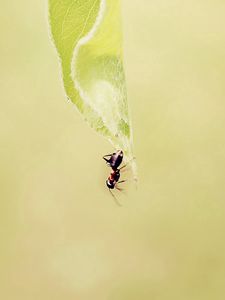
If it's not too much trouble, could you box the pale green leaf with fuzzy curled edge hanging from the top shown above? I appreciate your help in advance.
[49,0,133,175]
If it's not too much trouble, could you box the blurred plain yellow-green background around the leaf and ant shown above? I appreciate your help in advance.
[0,0,225,300]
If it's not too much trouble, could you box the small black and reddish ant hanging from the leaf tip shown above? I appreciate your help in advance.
[103,150,126,204]
